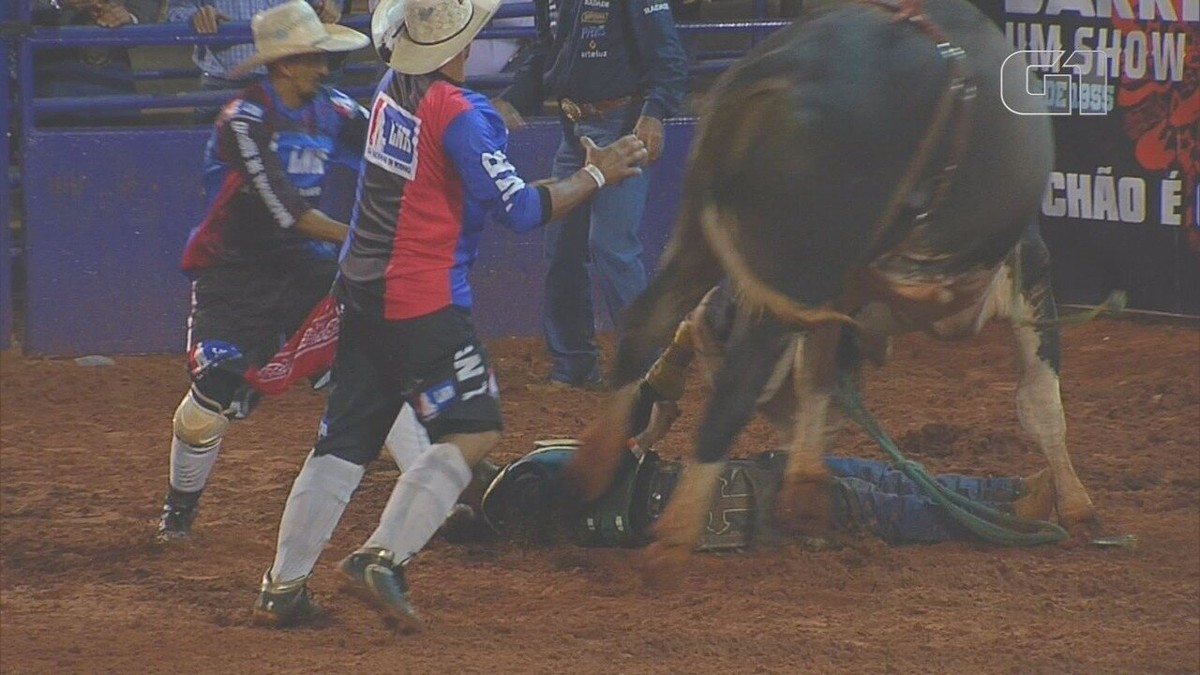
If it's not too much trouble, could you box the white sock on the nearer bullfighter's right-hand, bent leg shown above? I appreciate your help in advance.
[364,443,472,561]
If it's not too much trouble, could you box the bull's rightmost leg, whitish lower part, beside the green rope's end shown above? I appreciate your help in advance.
[1007,227,1096,528]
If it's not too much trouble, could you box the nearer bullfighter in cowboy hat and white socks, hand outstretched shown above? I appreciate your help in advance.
[253,0,648,632]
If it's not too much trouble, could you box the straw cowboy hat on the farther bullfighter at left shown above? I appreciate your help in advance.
[229,0,371,77]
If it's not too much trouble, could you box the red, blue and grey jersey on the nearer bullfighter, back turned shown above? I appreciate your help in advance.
[334,71,550,319]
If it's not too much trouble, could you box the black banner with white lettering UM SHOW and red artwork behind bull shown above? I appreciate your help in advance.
[1002,0,1200,316]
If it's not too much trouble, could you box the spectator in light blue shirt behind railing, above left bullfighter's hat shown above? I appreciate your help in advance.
[167,0,342,123]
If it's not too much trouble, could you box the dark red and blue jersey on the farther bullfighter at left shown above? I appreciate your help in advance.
[182,80,366,273]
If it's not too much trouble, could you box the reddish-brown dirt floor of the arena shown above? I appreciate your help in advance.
[0,321,1200,675]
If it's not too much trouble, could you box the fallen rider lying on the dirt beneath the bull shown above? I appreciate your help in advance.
[480,440,1022,550]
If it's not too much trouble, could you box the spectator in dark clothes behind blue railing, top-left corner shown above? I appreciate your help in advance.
[34,0,161,125]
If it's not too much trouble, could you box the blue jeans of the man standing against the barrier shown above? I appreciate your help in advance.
[542,107,649,384]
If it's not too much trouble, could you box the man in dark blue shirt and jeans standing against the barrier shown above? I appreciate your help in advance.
[496,0,688,388]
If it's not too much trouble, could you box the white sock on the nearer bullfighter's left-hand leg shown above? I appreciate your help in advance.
[271,453,366,583]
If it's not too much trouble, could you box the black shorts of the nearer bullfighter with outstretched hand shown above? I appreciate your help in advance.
[316,305,500,465]
